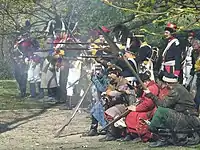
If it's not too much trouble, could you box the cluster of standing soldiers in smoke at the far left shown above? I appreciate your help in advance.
[12,18,66,100]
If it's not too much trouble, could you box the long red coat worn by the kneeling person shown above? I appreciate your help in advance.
[125,81,159,142]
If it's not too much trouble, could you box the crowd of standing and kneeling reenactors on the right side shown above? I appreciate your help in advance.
[85,23,200,147]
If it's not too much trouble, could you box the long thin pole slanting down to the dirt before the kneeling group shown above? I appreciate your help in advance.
[55,82,92,137]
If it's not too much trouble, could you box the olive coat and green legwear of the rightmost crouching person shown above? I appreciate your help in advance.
[146,77,200,146]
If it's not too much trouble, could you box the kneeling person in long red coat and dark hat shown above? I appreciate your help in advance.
[124,72,159,142]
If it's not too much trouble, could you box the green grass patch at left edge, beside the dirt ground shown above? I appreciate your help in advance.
[0,80,50,110]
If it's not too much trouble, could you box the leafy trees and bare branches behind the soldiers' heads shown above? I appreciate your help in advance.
[0,0,200,79]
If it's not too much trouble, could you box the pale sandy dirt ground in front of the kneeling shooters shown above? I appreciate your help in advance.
[0,108,197,150]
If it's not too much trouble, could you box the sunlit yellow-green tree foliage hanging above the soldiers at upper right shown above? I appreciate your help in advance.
[103,0,200,46]
